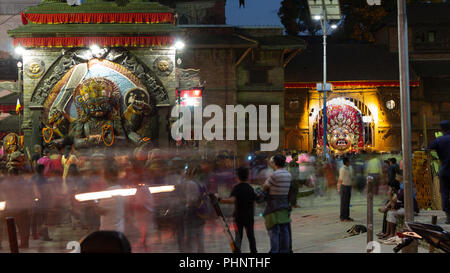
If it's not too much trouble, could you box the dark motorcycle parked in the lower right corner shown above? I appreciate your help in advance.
[393,222,450,253]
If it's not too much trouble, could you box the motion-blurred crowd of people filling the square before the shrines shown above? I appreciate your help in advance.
[0,124,446,253]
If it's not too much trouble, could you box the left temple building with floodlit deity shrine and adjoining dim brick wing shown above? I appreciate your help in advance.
[0,0,305,155]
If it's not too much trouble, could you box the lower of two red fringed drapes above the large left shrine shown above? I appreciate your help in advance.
[13,36,175,47]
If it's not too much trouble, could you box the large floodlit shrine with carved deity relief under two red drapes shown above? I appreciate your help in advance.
[8,0,201,151]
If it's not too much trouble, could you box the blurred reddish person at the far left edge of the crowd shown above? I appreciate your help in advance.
[3,168,33,248]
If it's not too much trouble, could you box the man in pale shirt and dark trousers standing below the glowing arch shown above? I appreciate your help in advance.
[337,157,353,222]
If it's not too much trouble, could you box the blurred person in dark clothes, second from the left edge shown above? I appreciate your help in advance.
[31,164,53,241]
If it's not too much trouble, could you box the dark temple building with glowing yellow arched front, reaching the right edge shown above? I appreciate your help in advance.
[284,3,450,152]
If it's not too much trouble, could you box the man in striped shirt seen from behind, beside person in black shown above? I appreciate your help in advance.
[263,154,292,253]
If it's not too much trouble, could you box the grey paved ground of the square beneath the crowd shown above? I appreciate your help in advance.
[0,187,450,253]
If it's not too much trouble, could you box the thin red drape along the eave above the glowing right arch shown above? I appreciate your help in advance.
[284,81,419,88]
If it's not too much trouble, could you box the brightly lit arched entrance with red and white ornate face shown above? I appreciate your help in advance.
[312,97,374,154]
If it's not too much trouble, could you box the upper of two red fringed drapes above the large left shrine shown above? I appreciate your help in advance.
[22,12,174,25]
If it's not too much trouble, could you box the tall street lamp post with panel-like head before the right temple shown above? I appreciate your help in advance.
[308,0,341,159]
